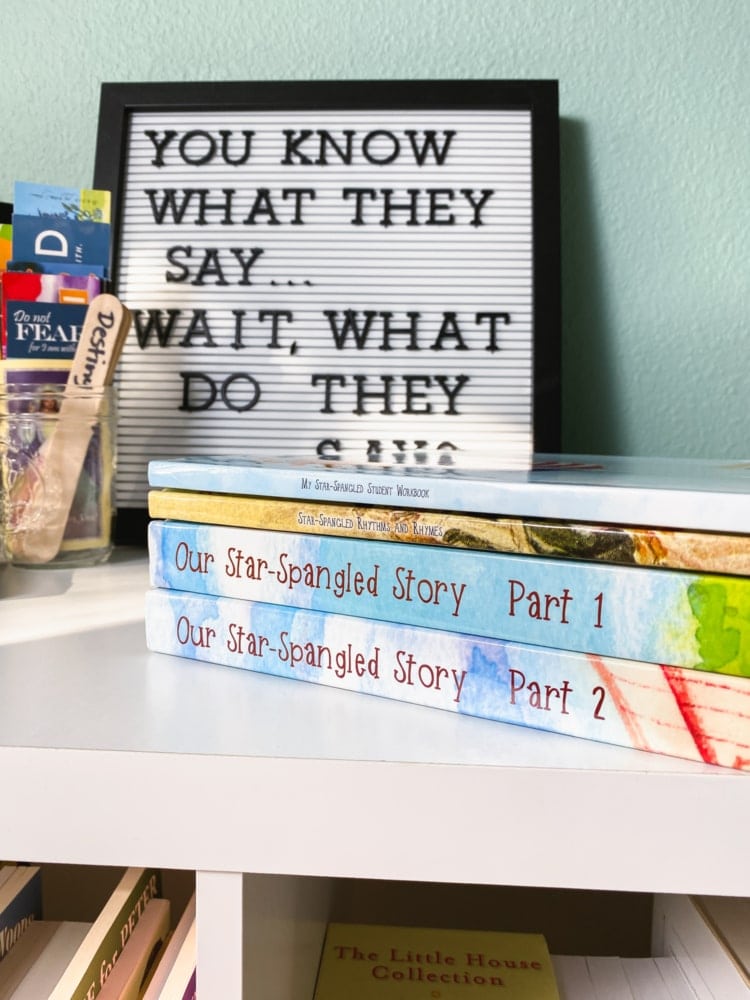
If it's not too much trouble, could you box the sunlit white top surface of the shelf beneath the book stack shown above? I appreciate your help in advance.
[0,550,747,780]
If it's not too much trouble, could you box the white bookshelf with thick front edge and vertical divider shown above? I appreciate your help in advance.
[0,550,750,1000]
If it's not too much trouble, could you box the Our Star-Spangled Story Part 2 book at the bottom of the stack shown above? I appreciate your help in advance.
[145,589,750,770]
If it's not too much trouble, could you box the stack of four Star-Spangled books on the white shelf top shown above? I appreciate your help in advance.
[146,455,750,769]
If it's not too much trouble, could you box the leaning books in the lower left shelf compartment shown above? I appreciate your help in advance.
[0,864,196,1000]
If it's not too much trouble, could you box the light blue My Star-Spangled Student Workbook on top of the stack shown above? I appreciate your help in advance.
[148,452,750,534]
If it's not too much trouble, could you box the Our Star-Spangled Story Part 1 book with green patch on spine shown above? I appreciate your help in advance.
[148,521,750,677]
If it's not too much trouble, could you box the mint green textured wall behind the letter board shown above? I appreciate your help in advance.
[0,0,750,457]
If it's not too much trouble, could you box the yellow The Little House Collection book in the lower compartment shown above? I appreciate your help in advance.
[314,923,560,1000]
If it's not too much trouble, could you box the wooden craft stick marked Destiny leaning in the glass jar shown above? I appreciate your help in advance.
[6,293,131,563]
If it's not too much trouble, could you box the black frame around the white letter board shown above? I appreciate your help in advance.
[93,80,561,541]
